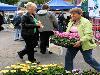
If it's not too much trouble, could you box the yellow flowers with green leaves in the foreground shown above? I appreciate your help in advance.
[0,61,66,75]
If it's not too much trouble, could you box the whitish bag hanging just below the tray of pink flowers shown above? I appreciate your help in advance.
[48,43,63,55]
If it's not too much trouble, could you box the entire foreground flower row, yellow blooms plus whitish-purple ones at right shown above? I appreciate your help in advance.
[0,61,100,75]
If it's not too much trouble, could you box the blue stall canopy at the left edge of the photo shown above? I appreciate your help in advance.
[0,3,17,11]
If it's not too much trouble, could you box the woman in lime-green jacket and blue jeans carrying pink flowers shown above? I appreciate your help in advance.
[65,8,100,72]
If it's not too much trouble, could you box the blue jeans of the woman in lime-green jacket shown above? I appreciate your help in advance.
[65,47,100,72]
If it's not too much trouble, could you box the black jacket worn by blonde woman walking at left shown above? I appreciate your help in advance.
[21,12,39,35]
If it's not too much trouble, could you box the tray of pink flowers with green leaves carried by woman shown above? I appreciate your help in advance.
[50,31,80,47]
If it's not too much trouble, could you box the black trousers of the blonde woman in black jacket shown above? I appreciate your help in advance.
[21,34,38,61]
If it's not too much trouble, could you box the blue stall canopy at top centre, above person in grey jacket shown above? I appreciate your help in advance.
[47,0,80,10]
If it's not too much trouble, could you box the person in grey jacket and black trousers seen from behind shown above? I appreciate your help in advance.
[36,4,57,54]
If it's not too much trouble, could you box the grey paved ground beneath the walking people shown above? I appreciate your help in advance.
[0,29,100,70]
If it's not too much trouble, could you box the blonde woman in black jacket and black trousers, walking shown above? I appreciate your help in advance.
[18,2,42,62]
